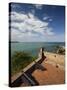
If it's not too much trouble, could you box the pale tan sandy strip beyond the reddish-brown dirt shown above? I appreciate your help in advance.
[44,52,65,69]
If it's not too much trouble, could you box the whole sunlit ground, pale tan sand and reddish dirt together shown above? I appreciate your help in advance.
[32,52,65,85]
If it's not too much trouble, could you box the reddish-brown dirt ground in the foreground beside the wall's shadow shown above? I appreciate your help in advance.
[32,59,65,85]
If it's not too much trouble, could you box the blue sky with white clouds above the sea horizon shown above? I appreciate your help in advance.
[9,3,65,42]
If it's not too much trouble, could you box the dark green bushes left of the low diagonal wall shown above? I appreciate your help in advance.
[11,52,36,75]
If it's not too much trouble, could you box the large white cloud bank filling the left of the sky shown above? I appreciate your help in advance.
[10,11,54,41]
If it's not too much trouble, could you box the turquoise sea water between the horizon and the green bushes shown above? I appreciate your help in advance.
[11,42,65,56]
